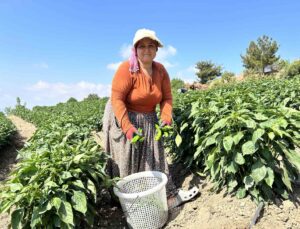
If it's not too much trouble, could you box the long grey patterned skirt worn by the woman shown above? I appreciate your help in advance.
[103,100,177,195]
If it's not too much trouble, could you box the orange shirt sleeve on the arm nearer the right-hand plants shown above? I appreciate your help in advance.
[160,66,173,122]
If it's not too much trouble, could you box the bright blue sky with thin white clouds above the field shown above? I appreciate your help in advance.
[0,0,300,110]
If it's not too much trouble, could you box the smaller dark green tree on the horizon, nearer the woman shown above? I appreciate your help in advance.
[196,61,222,83]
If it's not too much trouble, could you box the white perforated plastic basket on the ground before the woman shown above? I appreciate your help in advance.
[114,171,168,229]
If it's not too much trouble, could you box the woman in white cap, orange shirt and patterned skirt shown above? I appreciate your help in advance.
[103,29,198,207]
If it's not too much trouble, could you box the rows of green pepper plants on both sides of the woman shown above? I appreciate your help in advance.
[0,78,300,228]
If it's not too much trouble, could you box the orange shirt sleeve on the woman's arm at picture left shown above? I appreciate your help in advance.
[111,62,133,134]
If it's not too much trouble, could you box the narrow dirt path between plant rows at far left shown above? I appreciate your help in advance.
[0,116,36,229]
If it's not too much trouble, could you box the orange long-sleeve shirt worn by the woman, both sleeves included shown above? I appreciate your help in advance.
[111,61,172,133]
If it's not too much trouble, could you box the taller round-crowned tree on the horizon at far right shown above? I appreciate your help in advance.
[241,35,280,74]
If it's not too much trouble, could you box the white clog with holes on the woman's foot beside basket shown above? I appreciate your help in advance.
[168,187,199,210]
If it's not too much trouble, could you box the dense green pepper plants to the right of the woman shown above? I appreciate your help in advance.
[166,78,300,202]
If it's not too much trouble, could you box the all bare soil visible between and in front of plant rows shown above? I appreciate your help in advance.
[0,116,300,229]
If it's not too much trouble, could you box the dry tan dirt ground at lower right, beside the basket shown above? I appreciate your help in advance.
[165,163,300,229]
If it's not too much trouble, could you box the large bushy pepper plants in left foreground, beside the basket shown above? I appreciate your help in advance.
[0,120,113,228]
